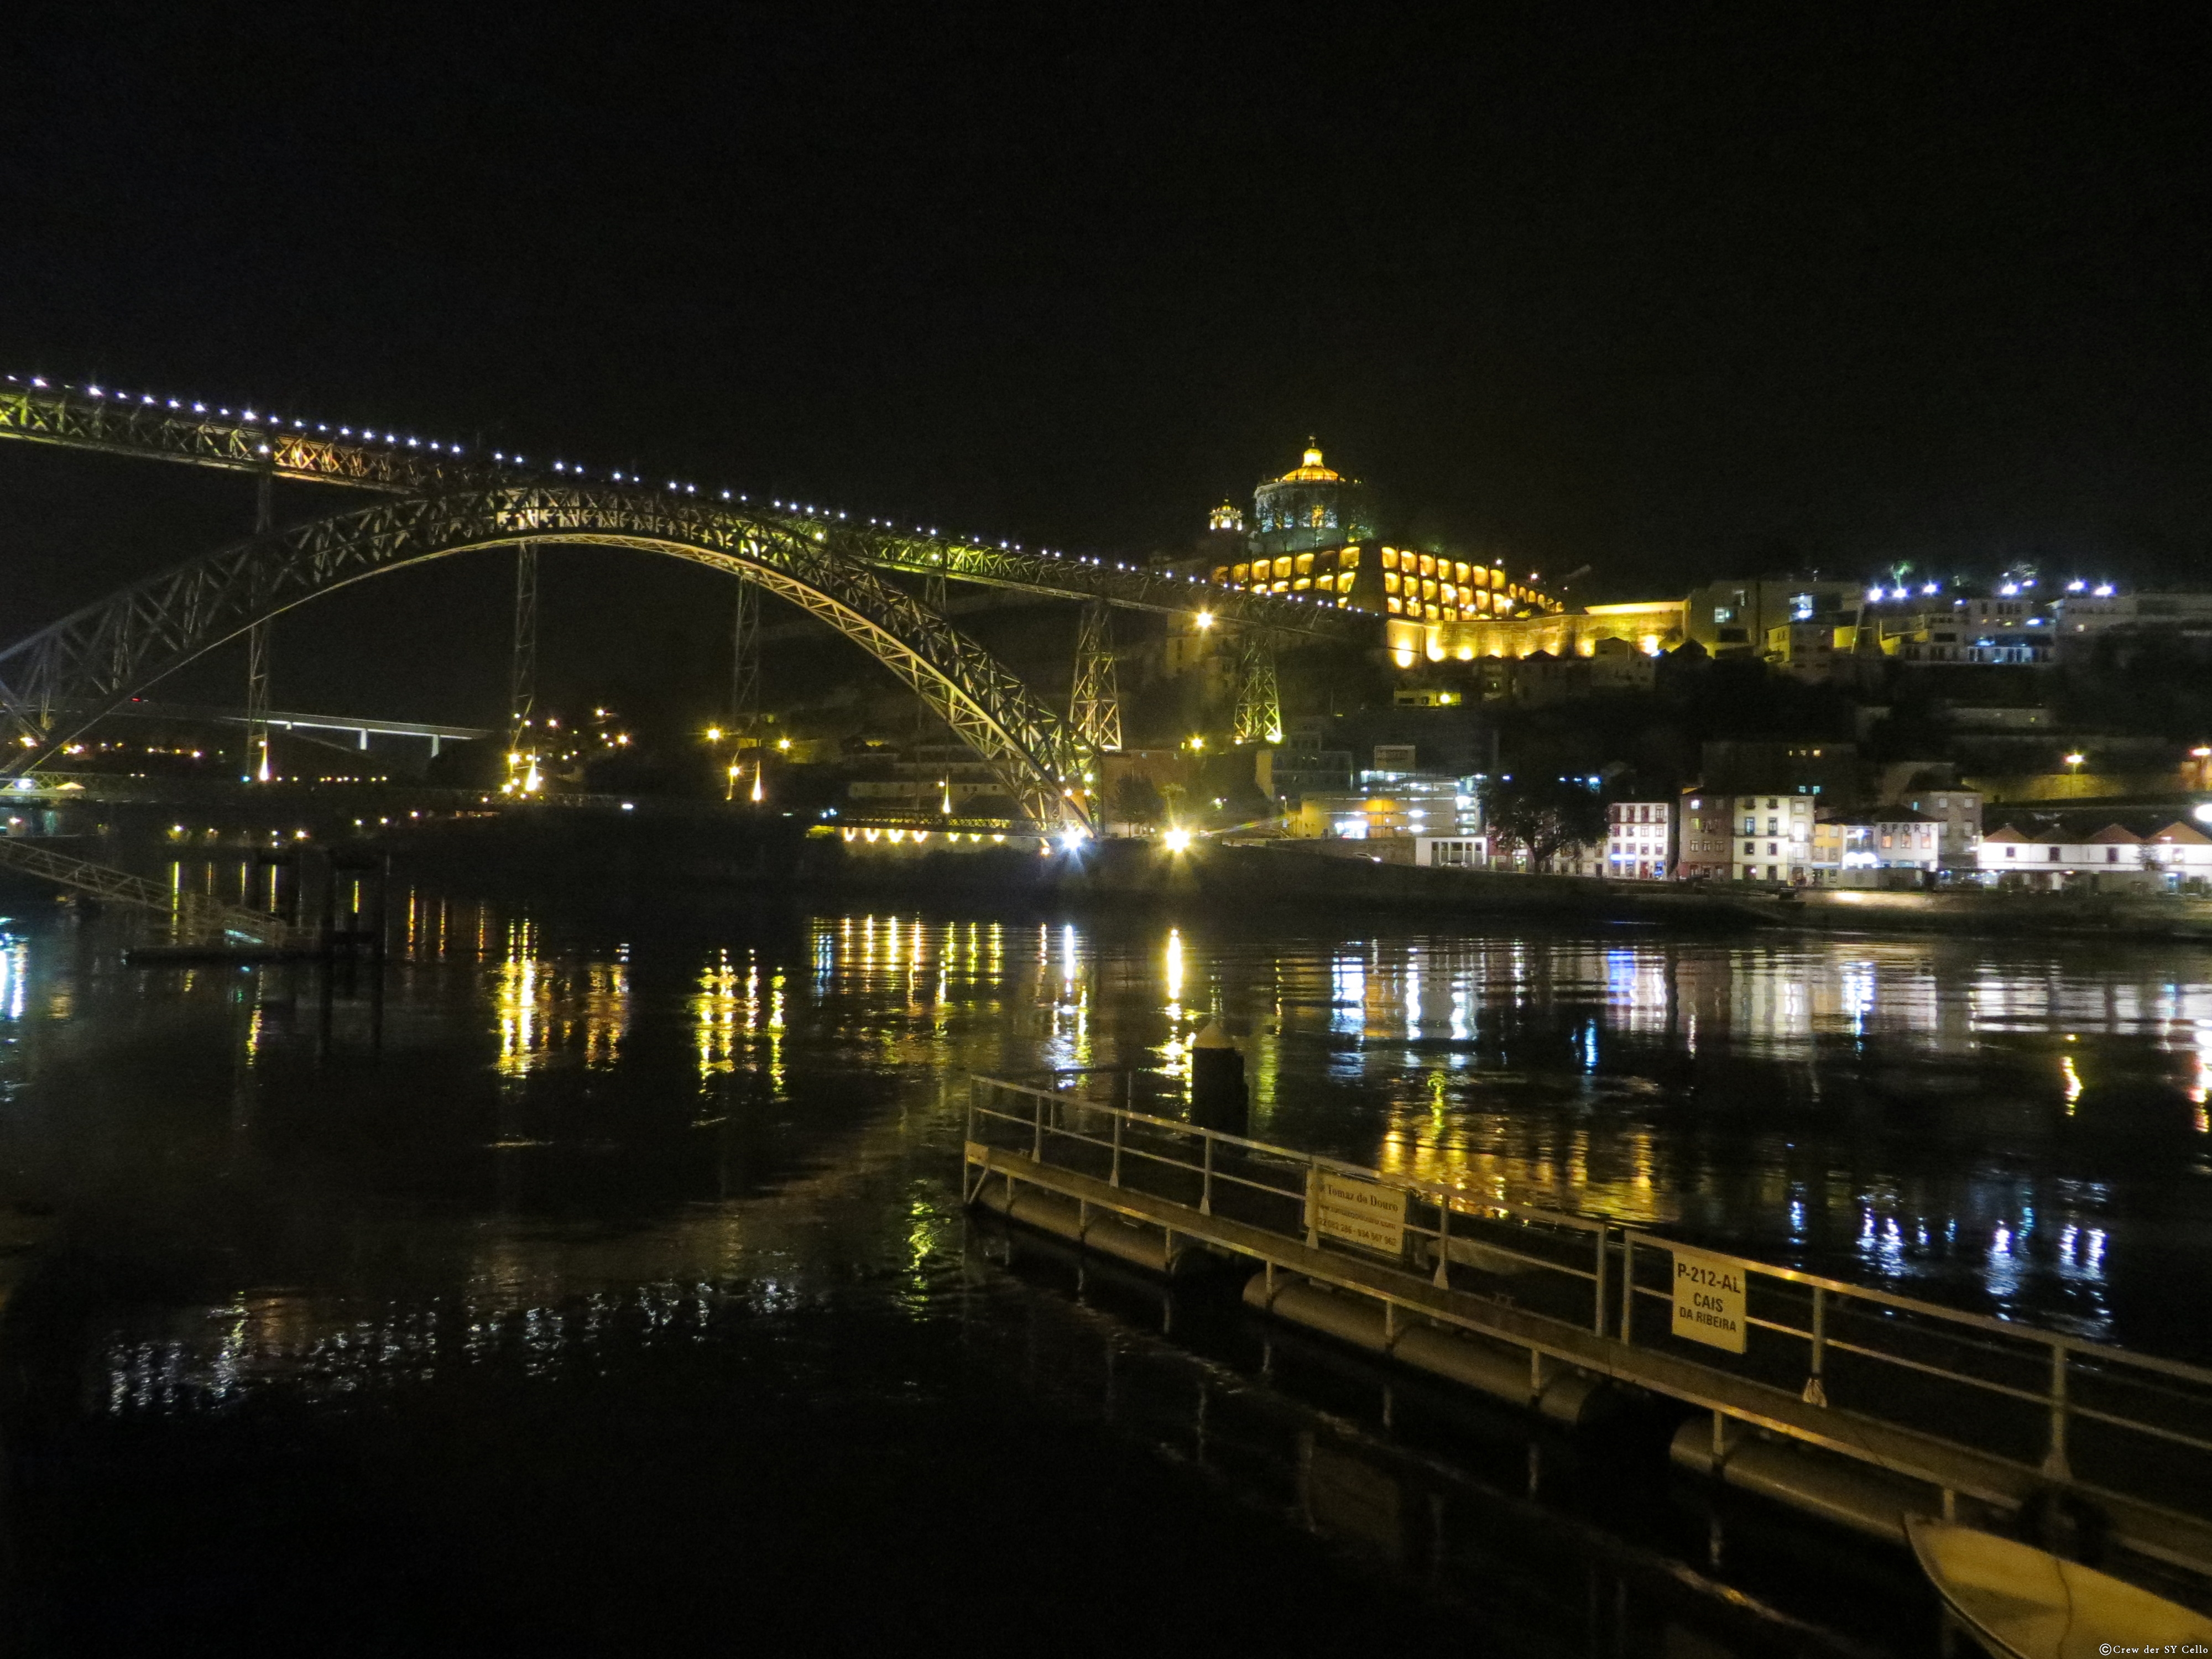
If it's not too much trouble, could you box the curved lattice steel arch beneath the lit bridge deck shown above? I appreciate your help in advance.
[0,484,1095,827]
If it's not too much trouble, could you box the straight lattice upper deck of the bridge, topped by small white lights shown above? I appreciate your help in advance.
[0,378,1380,641]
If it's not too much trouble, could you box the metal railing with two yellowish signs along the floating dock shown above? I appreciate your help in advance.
[967,1077,2212,1573]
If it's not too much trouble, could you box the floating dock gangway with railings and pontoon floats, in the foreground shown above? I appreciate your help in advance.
[962,1075,2212,1582]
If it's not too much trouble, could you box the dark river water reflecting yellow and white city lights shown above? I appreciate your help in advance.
[0,876,2212,1657]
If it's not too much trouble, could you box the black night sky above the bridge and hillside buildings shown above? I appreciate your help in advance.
[0,0,2212,717]
